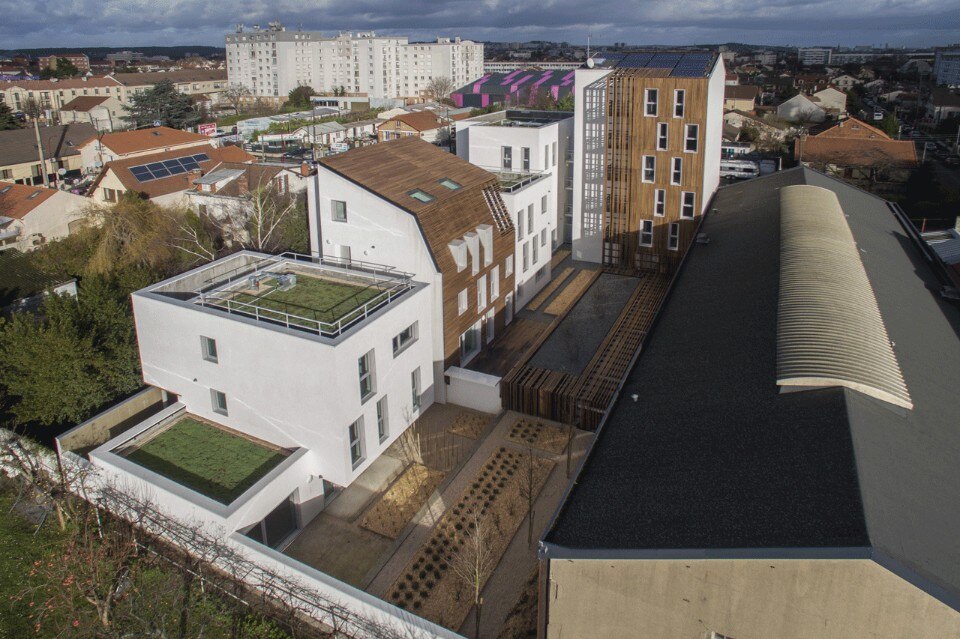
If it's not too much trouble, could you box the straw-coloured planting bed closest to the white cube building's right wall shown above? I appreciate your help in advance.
[360,464,445,539]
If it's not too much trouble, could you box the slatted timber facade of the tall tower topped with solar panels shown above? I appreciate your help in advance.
[603,69,709,272]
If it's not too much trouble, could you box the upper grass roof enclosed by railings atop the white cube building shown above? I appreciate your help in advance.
[233,275,381,323]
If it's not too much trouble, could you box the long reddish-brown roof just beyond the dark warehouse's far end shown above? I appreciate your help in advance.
[795,135,917,168]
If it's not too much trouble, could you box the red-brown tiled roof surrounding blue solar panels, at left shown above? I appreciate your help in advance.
[89,144,255,198]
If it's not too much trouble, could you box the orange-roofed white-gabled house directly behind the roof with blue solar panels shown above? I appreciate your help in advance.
[80,126,210,173]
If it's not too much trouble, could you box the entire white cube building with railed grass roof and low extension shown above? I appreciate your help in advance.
[83,252,434,546]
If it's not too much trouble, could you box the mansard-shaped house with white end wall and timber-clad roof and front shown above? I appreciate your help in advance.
[307,138,516,390]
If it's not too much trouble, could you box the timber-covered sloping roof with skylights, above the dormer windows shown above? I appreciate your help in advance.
[319,137,510,270]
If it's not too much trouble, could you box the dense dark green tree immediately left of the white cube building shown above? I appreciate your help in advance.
[0,277,142,425]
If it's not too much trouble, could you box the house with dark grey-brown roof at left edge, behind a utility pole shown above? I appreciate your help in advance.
[0,124,97,186]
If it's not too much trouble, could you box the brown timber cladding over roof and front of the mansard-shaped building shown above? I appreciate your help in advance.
[320,138,515,368]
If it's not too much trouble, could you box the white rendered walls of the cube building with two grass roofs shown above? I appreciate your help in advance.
[91,251,434,530]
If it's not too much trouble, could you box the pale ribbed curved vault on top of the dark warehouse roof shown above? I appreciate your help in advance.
[777,185,913,409]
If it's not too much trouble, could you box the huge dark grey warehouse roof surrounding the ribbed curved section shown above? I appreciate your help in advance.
[544,167,960,609]
